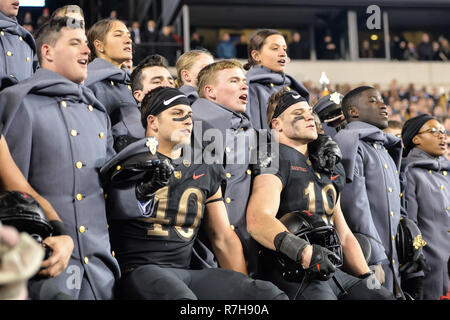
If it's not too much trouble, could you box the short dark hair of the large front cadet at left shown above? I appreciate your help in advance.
[36,16,83,63]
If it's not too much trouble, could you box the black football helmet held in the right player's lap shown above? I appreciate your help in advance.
[276,211,343,282]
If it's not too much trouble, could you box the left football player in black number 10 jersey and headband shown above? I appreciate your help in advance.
[103,87,287,300]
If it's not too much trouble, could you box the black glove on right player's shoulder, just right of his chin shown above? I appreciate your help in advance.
[308,134,342,173]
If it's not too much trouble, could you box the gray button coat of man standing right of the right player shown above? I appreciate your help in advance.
[334,121,403,292]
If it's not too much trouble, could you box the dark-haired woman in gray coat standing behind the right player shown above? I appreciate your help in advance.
[244,29,309,130]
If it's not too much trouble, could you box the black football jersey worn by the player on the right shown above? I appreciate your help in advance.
[268,144,345,224]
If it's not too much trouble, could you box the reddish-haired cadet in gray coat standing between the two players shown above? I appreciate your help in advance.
[192,60,257,276]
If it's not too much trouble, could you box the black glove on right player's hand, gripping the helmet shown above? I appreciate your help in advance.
[306,244,340,281]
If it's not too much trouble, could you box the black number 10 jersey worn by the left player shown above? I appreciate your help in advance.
[110,154,226,270]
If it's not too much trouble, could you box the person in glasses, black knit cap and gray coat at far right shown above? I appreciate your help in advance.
[402,114,450,300]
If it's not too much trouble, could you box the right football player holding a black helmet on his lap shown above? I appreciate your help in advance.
[247,90,393,300]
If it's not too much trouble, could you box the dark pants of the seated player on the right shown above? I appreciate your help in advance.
[266,269,395,300]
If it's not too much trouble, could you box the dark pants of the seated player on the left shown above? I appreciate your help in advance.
[119,265,288,300]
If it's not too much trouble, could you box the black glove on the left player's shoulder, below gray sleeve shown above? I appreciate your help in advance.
[135,159,174,202]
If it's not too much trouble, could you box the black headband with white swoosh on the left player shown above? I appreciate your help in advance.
[145,88,191,118]
